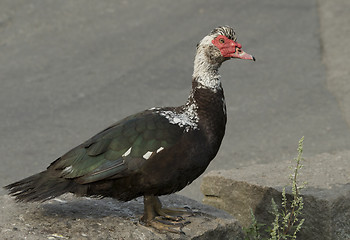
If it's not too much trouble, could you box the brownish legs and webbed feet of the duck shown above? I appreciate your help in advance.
[141,195,190,233]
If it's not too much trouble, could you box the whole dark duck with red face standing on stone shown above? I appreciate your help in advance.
[5,26,255,232]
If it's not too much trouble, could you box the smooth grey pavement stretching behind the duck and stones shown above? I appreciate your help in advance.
[0,0,350,200]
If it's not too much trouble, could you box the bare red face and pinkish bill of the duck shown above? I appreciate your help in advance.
[212,35,255,61]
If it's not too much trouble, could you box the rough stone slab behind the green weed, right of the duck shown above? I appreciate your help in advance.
[201,151,350,240]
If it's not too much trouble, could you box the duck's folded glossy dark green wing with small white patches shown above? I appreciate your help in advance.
[49,110,183,183]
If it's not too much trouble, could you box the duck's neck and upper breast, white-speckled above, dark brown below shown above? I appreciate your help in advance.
[183,51,226,159]
